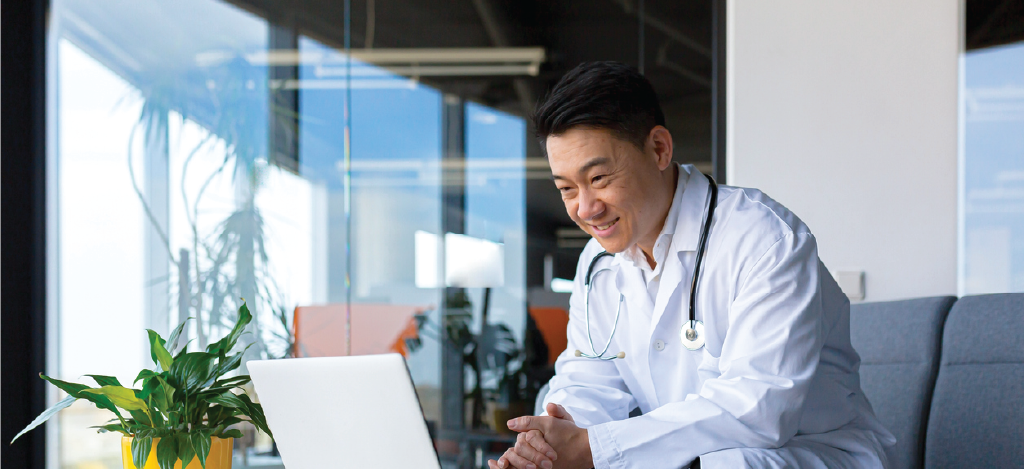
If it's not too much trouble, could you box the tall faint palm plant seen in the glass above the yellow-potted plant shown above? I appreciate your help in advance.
[129,58,297,366]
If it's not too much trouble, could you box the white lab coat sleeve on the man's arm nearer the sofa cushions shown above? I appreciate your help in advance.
[588,232,825,469]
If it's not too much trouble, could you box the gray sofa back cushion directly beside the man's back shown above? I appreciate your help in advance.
[851,297,955,469]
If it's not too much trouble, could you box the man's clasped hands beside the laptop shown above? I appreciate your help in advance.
[488,402,593,469]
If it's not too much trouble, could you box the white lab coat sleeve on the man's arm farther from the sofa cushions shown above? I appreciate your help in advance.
[542,241,637,428]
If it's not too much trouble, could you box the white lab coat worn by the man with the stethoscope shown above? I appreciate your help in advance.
[545,165,895,469]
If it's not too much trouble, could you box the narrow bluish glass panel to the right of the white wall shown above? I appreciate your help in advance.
[958,42,1025,295]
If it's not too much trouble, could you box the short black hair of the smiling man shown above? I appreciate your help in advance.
[532,61,665,155]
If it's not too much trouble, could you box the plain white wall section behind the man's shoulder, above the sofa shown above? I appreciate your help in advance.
[727,0,964,301]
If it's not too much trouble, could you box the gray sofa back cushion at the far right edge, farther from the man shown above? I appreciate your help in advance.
[926,294,1025,468]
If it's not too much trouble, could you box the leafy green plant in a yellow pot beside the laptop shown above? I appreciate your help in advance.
[11,300,271,469]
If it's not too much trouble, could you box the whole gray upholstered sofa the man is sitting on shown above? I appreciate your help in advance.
[535,294,1025,469]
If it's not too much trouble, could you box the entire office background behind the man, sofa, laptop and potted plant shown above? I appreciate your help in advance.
[0,0,1025,469]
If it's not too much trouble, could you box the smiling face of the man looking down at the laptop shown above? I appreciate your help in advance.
[545,128,671,253]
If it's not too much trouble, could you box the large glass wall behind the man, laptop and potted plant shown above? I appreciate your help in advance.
[47,0,713,468]
